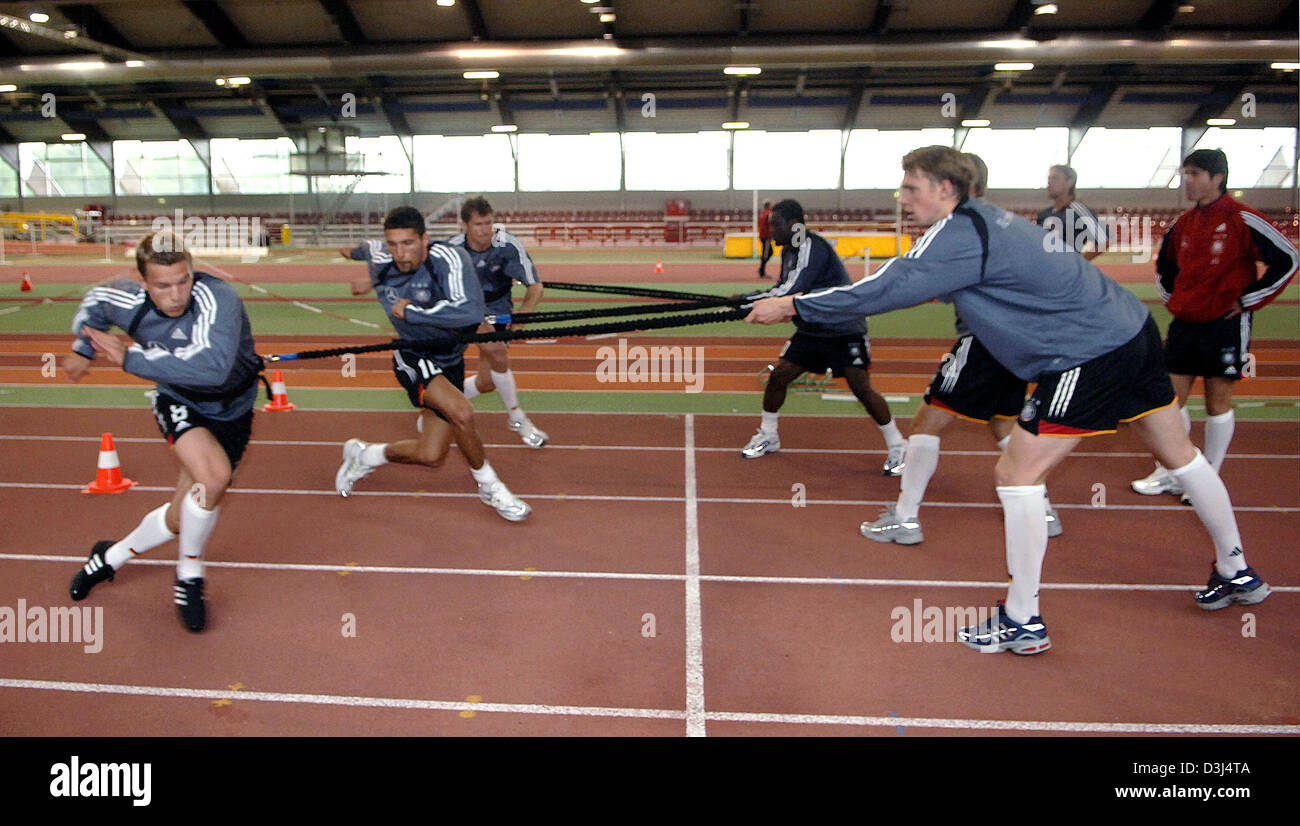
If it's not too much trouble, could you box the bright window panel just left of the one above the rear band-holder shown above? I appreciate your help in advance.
[623,131,731,191]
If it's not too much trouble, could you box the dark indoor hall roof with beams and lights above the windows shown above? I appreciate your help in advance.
[0,0,1300,143]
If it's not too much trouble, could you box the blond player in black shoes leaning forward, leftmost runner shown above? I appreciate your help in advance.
[64,232,261,631]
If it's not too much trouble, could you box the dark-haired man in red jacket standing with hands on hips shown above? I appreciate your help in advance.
[1132,150,1300,501]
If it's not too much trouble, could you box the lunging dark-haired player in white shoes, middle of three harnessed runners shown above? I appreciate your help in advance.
[334,207,532,522]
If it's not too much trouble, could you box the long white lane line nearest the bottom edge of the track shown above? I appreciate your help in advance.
[0,678,1300,735]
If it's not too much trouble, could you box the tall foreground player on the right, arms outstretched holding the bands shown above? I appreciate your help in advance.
[749,146,1269,654]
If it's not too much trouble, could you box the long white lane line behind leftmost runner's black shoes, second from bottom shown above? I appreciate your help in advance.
[0,553,1300,595]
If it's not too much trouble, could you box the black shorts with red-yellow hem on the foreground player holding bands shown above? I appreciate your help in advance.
[1019,316,1175,437]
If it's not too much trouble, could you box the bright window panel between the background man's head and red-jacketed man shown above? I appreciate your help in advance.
[1071,126,1183,189]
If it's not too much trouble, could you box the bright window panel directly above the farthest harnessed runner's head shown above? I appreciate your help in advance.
[413,135,515,193]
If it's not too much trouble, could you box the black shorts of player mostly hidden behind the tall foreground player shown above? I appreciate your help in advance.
[926,336,1028,421]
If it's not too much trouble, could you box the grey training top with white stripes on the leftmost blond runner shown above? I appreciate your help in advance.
[73,272,261,421]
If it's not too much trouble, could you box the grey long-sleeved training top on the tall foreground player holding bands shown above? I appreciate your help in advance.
[794,198,1151,381]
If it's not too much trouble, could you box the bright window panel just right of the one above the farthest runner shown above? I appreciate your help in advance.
[519,131,623,193]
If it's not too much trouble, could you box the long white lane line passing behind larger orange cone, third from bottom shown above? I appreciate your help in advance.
[0,481,1300,514]
